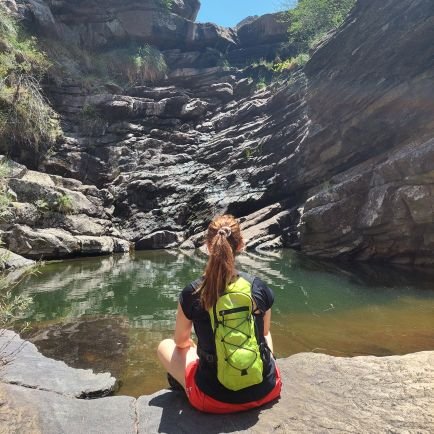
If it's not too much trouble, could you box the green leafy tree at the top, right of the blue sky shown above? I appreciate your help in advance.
[286,0,356,53]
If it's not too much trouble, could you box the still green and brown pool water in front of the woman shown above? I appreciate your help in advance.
[13,250,434,396]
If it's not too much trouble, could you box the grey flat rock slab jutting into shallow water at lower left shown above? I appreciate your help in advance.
[0,330,116,398]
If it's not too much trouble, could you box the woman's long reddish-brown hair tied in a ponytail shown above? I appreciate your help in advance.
[199,215,244,310]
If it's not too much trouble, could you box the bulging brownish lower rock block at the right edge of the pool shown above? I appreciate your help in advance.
[299,140,434,265]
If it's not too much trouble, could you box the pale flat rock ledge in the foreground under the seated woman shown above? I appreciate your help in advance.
[0,330,434,434]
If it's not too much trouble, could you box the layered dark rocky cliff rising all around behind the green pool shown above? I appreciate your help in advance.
[3,0,434,265]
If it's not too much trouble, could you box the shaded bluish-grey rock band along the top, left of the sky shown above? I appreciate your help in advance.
[17,0,236,50]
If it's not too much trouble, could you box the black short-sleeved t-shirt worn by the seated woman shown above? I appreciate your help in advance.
[179,272,276,404]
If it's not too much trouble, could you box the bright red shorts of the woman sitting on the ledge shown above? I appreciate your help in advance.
[185,360,282,413]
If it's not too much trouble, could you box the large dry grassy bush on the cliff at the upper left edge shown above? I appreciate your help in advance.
[0,6,60,154]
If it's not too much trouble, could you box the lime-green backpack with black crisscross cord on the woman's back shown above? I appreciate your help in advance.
[209,273,263,391]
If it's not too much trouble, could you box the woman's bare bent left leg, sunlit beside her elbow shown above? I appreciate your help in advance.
[157,339,198,389]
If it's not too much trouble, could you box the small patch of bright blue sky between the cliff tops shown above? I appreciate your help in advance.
[196,0,294,27]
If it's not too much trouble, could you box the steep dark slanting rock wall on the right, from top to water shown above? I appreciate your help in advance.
[292,1,434,264]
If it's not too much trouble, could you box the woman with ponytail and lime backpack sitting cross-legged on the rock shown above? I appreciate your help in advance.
[158,215,282,413]
